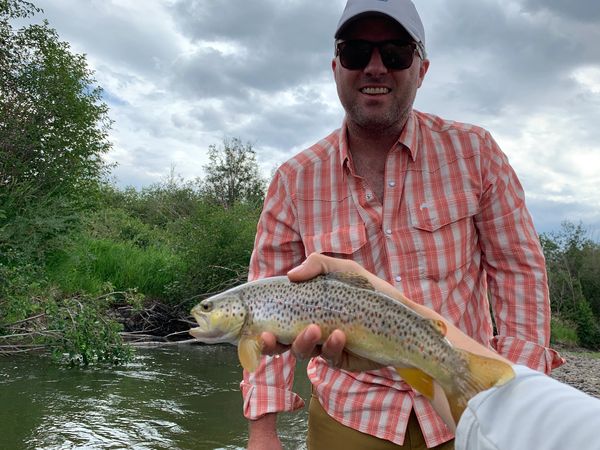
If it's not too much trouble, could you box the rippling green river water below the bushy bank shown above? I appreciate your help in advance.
[0,345,310,450]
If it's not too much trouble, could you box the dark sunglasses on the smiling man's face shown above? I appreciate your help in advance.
[335,39,417,70]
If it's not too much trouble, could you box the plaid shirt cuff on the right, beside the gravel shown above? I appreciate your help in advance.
[491,336,565,374]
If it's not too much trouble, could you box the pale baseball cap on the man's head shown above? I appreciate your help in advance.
[334,0,425,55]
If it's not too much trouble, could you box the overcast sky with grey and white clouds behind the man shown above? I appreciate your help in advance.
[19,0,600,238]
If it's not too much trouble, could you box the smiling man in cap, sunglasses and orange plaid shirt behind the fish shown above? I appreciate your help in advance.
[242,0,562,450]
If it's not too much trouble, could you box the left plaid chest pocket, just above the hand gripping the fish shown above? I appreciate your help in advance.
[302,224,367,260]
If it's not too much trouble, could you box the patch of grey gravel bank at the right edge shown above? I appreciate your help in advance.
[552,349,600,398]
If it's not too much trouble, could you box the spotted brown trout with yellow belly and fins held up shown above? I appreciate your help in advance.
[190,273,514,422]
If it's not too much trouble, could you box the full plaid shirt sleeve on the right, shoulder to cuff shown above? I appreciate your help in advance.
[475,134,564,373]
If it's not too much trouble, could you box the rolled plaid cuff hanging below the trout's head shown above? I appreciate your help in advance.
[240,381,304,420]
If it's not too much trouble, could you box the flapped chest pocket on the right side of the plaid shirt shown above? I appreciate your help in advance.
[409,191,479,281]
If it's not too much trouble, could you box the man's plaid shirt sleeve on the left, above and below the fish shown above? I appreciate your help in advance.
[240,168,305,420]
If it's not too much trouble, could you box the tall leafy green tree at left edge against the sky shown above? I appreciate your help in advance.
[0,0,110,202]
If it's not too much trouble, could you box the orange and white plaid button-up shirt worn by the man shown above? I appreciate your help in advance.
[241,111,563,447]
